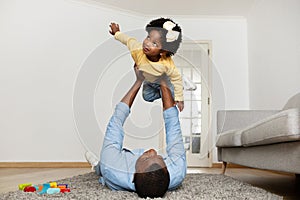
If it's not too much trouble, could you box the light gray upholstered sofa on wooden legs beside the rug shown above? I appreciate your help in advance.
[216,93,300,177]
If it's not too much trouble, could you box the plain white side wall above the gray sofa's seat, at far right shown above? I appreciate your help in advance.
[248,0,300,109]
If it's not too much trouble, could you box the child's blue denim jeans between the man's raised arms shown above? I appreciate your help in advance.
[143,78,174,102]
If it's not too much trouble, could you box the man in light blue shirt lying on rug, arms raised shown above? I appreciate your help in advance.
[85,67,186,198]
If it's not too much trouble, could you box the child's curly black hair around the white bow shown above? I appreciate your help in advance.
[146,18,182,56]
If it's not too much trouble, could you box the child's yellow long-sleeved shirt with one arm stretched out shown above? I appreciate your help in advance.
[115,31,183,101]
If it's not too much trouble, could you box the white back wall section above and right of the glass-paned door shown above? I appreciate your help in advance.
[178,17,249,109]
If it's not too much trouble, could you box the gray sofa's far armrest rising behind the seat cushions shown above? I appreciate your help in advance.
[217,110,281,134]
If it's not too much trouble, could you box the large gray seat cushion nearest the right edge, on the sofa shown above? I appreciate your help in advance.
[241,108,300,146]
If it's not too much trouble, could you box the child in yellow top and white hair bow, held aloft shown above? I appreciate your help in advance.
[109,18,184,111]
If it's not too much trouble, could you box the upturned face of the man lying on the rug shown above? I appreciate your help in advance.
[135,149,166,173]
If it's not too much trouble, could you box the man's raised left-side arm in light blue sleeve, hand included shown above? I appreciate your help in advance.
[100,67,143,190]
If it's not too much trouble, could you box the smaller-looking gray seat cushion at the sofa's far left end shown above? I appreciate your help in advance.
[216,130,242,147]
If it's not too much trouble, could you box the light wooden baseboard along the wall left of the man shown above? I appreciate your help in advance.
[0,162,91,168]
